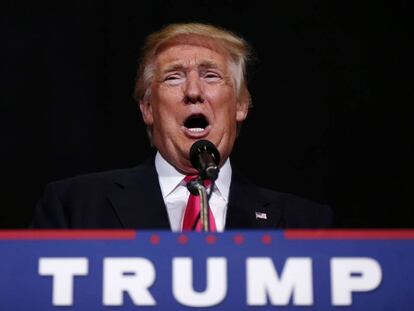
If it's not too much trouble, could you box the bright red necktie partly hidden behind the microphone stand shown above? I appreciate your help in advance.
[183,175,217,232]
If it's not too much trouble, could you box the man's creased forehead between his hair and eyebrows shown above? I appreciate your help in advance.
[154,42,228,70]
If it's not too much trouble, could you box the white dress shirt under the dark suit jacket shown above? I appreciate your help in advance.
[155,152,231,232]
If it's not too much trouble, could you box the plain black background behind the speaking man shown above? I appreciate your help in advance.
[0,0,414,228]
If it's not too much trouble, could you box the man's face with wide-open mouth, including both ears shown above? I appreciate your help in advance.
[140,40,248,174]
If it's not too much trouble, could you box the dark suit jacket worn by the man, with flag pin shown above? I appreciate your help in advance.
[32,158,332,229]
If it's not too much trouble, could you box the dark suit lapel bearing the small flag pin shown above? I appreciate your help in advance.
[226,170,282,229]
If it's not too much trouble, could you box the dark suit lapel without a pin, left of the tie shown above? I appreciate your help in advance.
[108,158,170,229]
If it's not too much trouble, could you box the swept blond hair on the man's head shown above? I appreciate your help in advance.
[134,23,251,106]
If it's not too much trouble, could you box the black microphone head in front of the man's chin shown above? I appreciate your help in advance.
[190,139,220,181]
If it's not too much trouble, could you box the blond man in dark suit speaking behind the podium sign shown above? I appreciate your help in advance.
[33,23,331,231]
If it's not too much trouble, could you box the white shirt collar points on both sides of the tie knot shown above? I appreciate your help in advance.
[155,152,232,202]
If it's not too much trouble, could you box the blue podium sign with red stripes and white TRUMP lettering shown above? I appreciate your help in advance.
[0,230,414,311]
